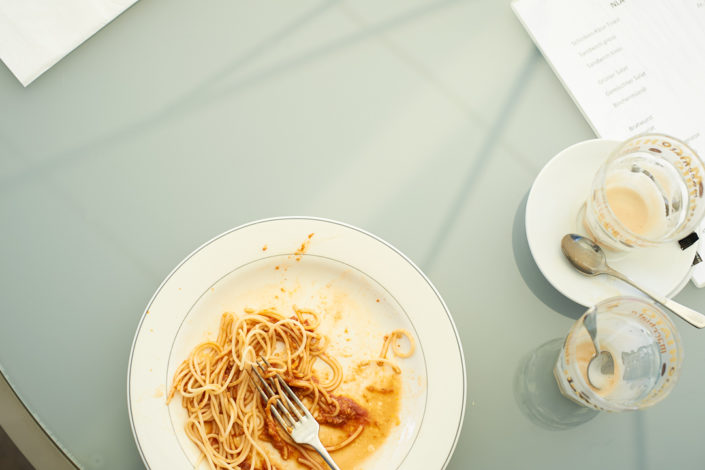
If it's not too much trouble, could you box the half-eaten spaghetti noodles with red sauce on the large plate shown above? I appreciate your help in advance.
[167,307,414,470]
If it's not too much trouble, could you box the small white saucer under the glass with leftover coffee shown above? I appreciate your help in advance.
[526,139,698,306]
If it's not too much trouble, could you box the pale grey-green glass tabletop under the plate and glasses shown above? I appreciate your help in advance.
[0,0,705,470]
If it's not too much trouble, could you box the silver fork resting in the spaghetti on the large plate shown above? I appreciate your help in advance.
[250,356,340,470]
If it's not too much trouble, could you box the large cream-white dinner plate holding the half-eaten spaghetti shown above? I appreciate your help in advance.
[127,217,466,470]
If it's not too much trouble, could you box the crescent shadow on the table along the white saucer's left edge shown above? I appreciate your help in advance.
[512,191,585,320]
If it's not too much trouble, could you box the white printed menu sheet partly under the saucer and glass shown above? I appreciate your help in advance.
[512,0,705,287]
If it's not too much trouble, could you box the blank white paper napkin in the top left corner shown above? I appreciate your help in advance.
[0,0,137,86]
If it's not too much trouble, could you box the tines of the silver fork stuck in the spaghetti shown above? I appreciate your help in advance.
[250,356,312,433]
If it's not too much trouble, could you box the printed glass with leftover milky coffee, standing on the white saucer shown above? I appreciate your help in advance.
[580,134,705,251]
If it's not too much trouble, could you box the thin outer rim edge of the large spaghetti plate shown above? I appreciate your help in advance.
[126,215,468,469]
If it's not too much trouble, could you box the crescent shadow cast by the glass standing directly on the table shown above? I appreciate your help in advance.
[514,338,599,430]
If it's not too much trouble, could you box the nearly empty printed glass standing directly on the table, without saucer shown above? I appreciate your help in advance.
[554,297,683,411]
